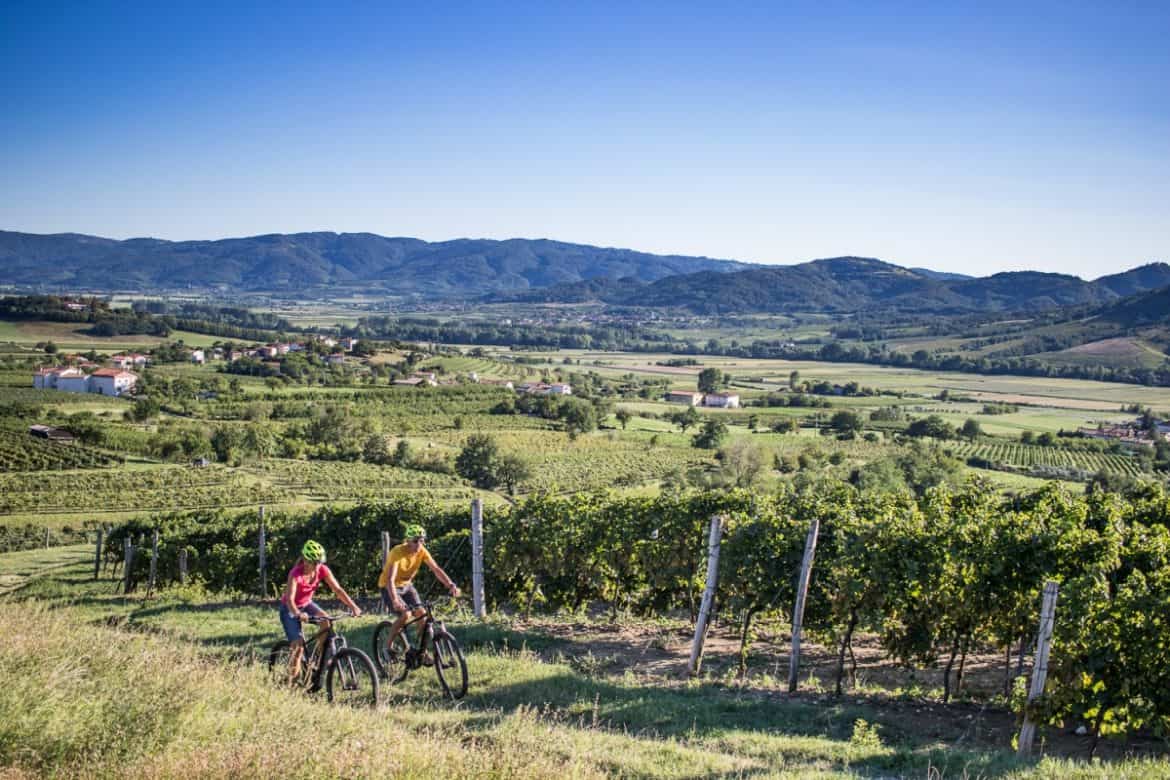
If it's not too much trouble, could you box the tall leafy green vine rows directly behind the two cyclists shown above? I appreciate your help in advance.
[111,481,1170,748]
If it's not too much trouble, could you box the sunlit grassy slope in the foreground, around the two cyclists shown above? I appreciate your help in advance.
[0,555,1170,778]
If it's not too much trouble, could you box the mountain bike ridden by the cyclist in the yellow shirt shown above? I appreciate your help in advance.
[373,601,467,699]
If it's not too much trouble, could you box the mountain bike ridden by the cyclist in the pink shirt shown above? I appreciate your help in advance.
[268,613,379,706]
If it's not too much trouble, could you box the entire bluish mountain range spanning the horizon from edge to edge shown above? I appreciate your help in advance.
[0,232,1170,313]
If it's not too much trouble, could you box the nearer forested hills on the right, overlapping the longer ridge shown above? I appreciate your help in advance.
[498,257,1170,315]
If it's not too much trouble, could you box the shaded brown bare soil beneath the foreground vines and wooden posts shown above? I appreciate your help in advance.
[514,619,1168,759]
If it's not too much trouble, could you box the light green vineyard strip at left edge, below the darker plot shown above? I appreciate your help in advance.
[0,467,290,519]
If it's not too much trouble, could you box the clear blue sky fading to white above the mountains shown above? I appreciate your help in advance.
[0,0,1170,277]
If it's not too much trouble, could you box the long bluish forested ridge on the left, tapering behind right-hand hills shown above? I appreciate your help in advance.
[0,232,748,296]
